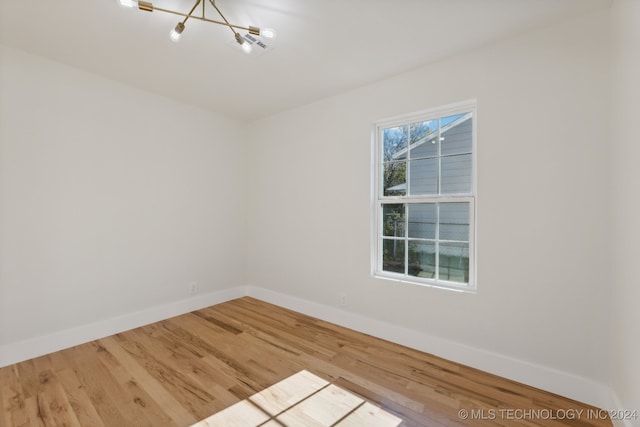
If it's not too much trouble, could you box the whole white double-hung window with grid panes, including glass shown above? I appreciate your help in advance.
[372,102,476,291]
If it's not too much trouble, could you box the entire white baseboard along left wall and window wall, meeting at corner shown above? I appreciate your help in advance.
[0,286,620,418]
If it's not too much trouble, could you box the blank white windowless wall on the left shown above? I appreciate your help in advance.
[0,45,246,356]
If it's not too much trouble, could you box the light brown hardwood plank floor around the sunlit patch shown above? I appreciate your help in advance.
[0,297,612,427]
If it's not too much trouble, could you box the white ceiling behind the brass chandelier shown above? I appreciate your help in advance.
[0,0,610,120]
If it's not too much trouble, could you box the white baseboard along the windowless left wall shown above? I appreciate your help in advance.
[0,286,247,367]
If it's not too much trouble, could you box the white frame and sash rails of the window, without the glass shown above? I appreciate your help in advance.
[371,99,478,293]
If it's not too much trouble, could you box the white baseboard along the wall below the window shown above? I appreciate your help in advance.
[247,286,626,412]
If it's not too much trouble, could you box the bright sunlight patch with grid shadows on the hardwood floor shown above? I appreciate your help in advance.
[191,370,402,427]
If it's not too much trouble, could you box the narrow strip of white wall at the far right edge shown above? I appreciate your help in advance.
[609,0,640,425]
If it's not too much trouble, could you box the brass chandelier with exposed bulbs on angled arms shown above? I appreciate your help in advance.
[118,0,276,53]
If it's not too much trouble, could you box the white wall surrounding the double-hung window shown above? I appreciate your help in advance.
[248,10,611,383]
